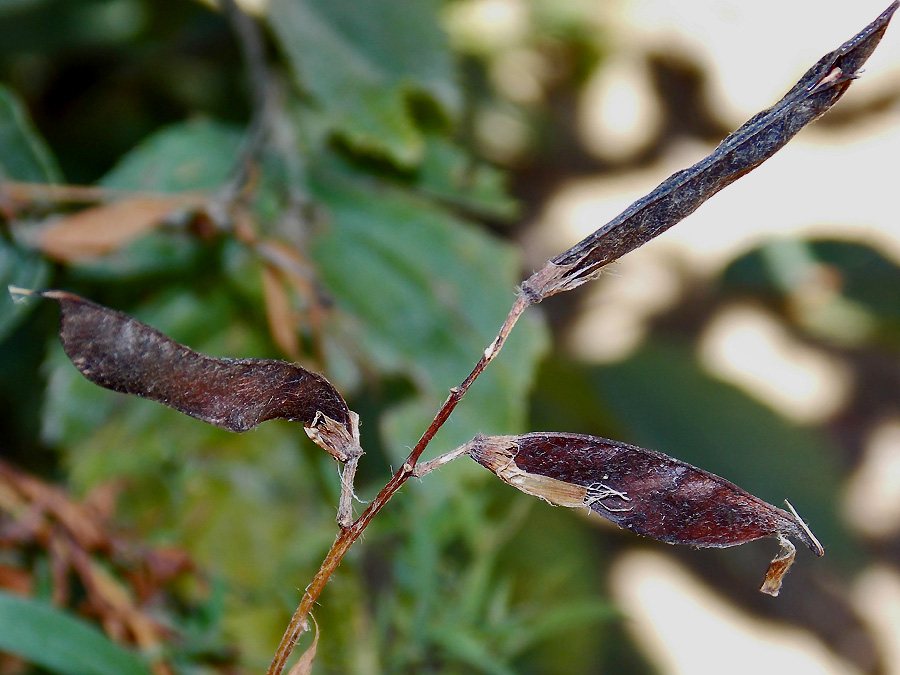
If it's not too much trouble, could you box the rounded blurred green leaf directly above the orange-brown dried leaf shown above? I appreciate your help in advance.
[100,120,244,192]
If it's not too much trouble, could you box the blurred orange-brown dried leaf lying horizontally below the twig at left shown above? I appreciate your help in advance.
[38,196,201,261]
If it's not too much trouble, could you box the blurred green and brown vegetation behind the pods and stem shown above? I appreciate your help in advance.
[0,0,900,673]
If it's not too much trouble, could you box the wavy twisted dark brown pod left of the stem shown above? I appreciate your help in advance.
[22,289,362,461]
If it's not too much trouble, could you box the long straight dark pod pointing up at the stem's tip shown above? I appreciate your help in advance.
[521,1,900,304]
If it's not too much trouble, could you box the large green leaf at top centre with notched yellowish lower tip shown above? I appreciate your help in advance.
[269,0,459,167]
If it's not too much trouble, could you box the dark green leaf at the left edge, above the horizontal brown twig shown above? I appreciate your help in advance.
[0,85,62,183]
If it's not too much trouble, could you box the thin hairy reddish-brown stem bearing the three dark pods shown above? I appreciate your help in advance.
[267,293,533,675]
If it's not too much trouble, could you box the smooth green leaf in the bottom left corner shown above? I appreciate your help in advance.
[0,591,150,675]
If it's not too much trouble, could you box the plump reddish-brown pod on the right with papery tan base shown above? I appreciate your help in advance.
[466,433,825,595]
